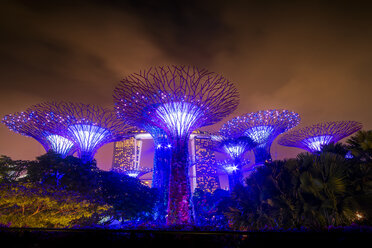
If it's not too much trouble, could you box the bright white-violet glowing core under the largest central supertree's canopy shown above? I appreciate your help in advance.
[156,102,203,136]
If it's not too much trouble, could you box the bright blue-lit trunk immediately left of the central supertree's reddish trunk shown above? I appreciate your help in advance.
[152,142,171,223]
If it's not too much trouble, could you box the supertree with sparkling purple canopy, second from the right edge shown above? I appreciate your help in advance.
[220,109,300,165]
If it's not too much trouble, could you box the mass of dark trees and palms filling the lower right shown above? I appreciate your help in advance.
[226,132,372,230]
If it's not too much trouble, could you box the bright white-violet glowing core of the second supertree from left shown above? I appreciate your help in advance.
[68,124,111,153]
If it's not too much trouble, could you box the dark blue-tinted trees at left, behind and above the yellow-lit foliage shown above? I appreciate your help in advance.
[0,151,156,227]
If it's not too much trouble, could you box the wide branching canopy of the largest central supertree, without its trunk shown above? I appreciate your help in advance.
[114,66,239,138]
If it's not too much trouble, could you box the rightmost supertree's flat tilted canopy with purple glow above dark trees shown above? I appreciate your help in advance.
[278,121,362,152]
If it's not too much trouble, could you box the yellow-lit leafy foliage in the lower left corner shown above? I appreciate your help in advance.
[0,183,110,228]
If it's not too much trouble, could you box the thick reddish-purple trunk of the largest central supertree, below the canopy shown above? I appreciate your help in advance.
[167,137,192,225]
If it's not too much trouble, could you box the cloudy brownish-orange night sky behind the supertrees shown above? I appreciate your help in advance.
[0,0,372,169]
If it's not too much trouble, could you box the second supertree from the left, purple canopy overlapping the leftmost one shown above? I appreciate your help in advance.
[30,102,136,163]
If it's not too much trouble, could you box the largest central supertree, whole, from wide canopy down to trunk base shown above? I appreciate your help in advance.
[114,66,238,224]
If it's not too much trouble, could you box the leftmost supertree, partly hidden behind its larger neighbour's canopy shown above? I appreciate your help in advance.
[2,109,75,157]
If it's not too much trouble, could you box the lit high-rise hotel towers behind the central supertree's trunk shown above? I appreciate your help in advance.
[112,131,220,192]
